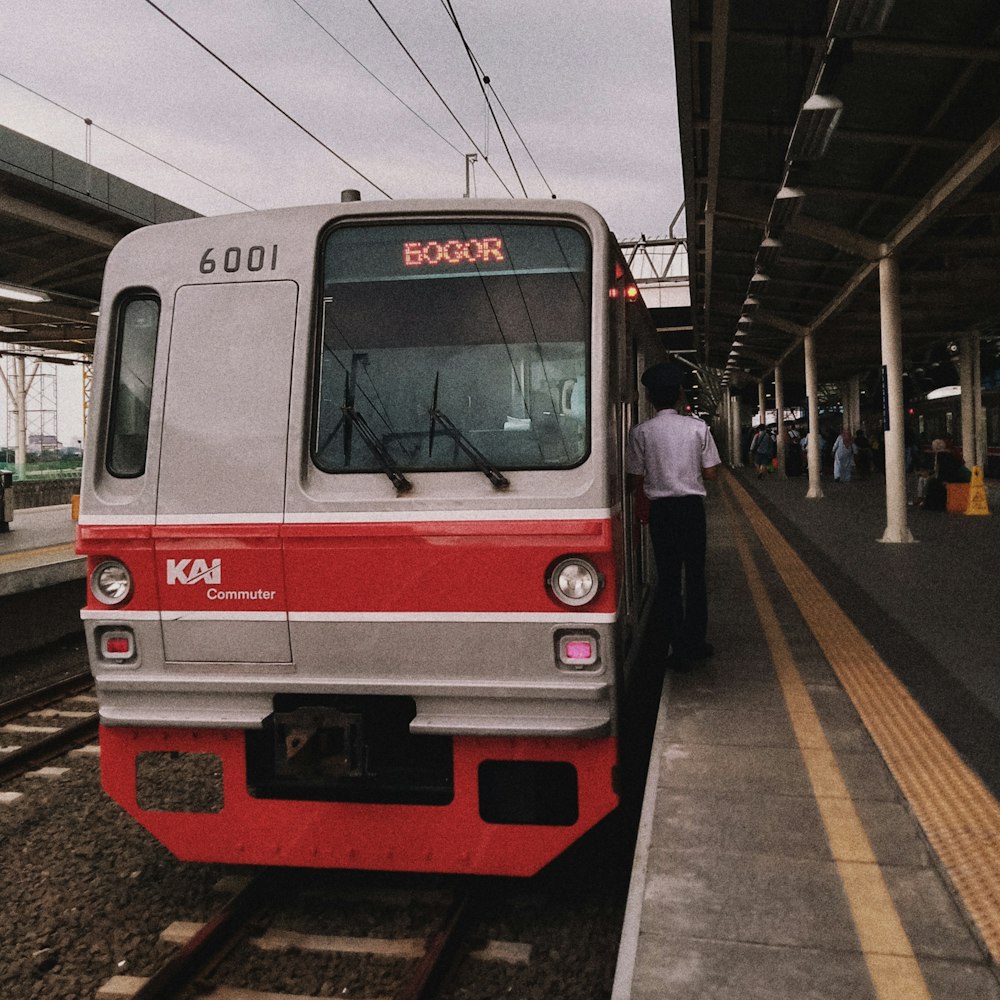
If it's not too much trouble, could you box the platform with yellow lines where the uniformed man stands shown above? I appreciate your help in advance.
[612,473,1000,1000]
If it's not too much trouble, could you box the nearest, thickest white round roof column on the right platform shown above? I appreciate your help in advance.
[878,253,913,542]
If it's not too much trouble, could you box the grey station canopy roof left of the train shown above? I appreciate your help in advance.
[0,127,197,354]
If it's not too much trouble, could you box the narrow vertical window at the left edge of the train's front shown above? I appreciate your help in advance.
[107,293,160,479]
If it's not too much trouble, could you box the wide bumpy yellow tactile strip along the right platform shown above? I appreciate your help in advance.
[725,475,1000,961]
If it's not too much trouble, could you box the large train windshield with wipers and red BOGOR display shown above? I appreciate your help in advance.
[313,220,592,479]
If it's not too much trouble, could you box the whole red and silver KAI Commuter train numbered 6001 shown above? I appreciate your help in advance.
[77,199,660,875]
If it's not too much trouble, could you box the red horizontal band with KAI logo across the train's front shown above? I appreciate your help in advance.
[77,519,616,614]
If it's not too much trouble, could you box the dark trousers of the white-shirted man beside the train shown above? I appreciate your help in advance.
[649,496,708,656]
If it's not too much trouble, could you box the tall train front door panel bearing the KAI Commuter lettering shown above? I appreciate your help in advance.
[153,281,298,664]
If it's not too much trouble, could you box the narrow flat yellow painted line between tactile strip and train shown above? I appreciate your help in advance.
[725,480,931,1000]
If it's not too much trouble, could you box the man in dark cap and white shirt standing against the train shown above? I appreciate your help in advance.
[625,363,722,669]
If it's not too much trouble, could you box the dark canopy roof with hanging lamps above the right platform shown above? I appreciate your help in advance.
[672,0,1000,394]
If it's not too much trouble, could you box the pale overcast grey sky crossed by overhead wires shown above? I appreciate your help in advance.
[0,0,683,440]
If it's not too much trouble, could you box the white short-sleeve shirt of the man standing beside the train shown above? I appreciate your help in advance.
[625,410,722,500]
